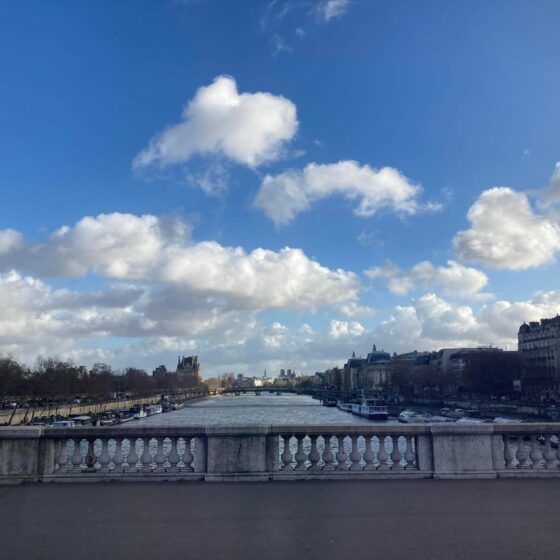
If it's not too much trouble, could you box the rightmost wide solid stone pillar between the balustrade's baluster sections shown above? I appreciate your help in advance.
[430,424,496,478]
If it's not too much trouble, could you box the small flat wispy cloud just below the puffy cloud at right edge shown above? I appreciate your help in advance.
[364,260,492,299]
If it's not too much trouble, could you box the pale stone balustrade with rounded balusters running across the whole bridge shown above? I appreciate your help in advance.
[0,424,560,483]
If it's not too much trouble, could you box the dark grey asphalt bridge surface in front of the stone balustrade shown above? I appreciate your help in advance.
[0,479,560,560]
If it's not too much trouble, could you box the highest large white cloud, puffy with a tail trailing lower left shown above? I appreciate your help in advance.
[133,76,298,169]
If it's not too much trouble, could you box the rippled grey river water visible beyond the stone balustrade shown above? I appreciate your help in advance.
[129,395,396,426]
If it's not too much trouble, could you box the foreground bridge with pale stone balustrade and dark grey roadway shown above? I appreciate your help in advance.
[0,423,560,560]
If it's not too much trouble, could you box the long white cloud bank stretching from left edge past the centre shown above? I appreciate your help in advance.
[0,213,360,310]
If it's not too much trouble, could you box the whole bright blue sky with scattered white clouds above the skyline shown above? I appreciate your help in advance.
[0,0,560,375]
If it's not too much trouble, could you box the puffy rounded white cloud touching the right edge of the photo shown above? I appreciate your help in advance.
[453,187,560,270]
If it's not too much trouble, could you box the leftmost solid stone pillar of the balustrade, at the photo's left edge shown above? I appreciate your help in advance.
[0,427,43,484]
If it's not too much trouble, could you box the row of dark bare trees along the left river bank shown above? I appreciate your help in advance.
[0,356,233,404]
